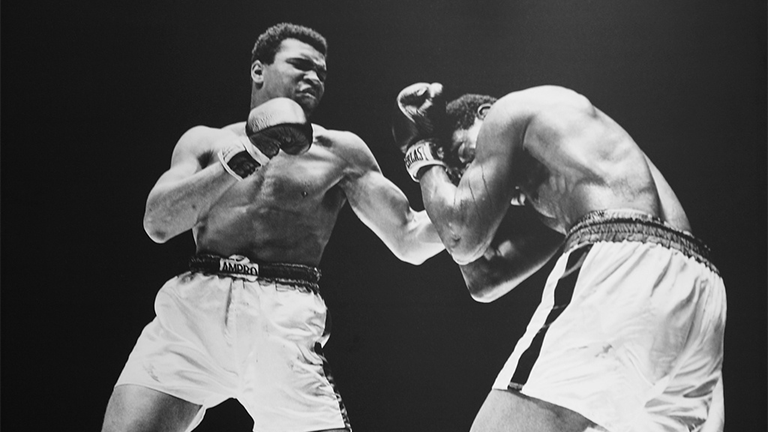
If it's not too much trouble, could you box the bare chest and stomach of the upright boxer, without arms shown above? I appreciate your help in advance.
[198,123,354,266]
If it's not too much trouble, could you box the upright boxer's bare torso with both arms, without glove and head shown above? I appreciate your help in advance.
[144,118,443,266]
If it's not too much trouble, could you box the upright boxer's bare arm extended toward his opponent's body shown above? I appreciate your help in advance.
[337,132,444,265]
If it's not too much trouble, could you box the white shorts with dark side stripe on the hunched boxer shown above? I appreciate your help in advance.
[493,211,726,432]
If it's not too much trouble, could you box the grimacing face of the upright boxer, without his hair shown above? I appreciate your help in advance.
[252,39,327,114]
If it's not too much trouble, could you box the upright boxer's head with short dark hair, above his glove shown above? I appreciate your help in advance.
[251,23,328,115]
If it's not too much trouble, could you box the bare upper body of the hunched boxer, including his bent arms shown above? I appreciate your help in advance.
[421,86,690,301]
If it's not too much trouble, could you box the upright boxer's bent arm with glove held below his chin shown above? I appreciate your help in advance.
[144,98,313,243]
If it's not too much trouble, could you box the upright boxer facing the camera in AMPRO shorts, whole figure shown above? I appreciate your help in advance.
[103,24,443,432]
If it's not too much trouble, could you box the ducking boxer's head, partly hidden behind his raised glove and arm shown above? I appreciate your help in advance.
[445,94,496,177]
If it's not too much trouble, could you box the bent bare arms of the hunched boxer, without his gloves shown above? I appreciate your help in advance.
[412,90,562,302]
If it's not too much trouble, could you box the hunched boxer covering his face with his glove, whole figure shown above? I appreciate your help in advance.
[393,83,726,432]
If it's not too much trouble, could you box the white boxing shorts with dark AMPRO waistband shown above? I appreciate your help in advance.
[116,255,351,432]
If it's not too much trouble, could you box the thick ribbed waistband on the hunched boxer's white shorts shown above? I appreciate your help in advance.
[564,210,718,273]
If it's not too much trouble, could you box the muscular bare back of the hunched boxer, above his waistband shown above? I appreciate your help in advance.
[521,88,688,232]
